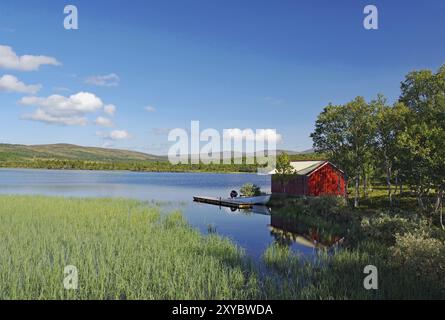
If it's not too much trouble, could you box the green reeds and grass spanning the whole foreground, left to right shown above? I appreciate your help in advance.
[0,196,445,300]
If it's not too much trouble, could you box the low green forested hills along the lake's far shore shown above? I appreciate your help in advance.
[0,144,323,172]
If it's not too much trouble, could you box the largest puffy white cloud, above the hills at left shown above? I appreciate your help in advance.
[19,92,103,125]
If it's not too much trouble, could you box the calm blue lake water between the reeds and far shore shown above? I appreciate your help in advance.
[0,169,314,259]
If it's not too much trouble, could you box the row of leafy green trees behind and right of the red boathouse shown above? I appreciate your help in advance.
[311,65,445,225]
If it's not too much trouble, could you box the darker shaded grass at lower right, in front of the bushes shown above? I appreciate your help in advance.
[263,243,445,300]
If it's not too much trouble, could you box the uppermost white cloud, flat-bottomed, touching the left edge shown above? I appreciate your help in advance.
[0,45,60,71]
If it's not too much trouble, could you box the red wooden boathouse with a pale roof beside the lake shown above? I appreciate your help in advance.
[271,161,346,196]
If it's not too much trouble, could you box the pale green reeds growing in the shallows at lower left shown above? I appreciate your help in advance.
[0,196,258,299]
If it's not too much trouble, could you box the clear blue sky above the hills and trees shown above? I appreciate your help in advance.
[0,0,445,154]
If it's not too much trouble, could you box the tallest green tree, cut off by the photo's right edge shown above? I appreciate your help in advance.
[400,65,445,228]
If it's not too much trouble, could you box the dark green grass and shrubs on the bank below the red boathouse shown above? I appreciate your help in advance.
[263,196,445,299]
